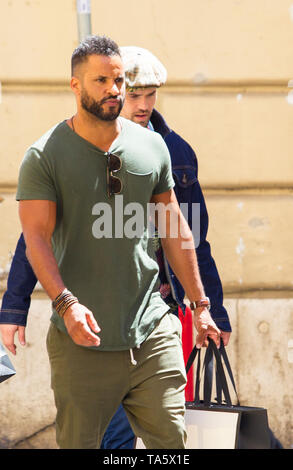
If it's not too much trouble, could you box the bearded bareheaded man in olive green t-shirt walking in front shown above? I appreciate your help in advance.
[2,36,220,449]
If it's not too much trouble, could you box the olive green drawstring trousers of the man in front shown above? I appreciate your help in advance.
[47,313,186,449]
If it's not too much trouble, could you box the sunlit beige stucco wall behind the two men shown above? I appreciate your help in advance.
[0,0,293,447]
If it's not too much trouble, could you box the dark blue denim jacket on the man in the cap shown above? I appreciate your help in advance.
[0,110,231,331]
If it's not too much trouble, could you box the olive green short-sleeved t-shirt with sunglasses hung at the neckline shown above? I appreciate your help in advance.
[16,117,174,350]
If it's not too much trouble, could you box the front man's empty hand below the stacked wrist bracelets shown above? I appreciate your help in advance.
[63,303,101,346]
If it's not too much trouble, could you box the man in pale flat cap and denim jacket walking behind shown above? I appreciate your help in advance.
[102,46,231,448]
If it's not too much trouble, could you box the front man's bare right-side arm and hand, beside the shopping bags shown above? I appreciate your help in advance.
[151,190,220,347]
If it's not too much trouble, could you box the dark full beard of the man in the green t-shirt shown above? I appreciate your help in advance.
[80,89,124,121]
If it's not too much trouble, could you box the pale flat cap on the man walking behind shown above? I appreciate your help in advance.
[120,46,167,88]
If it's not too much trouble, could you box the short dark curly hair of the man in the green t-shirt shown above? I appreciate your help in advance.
[71,36,121,76]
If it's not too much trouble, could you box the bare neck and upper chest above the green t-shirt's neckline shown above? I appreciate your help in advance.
[67,112,121,152]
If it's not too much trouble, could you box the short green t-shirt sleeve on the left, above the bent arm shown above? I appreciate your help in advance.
[16,147,57,202]
